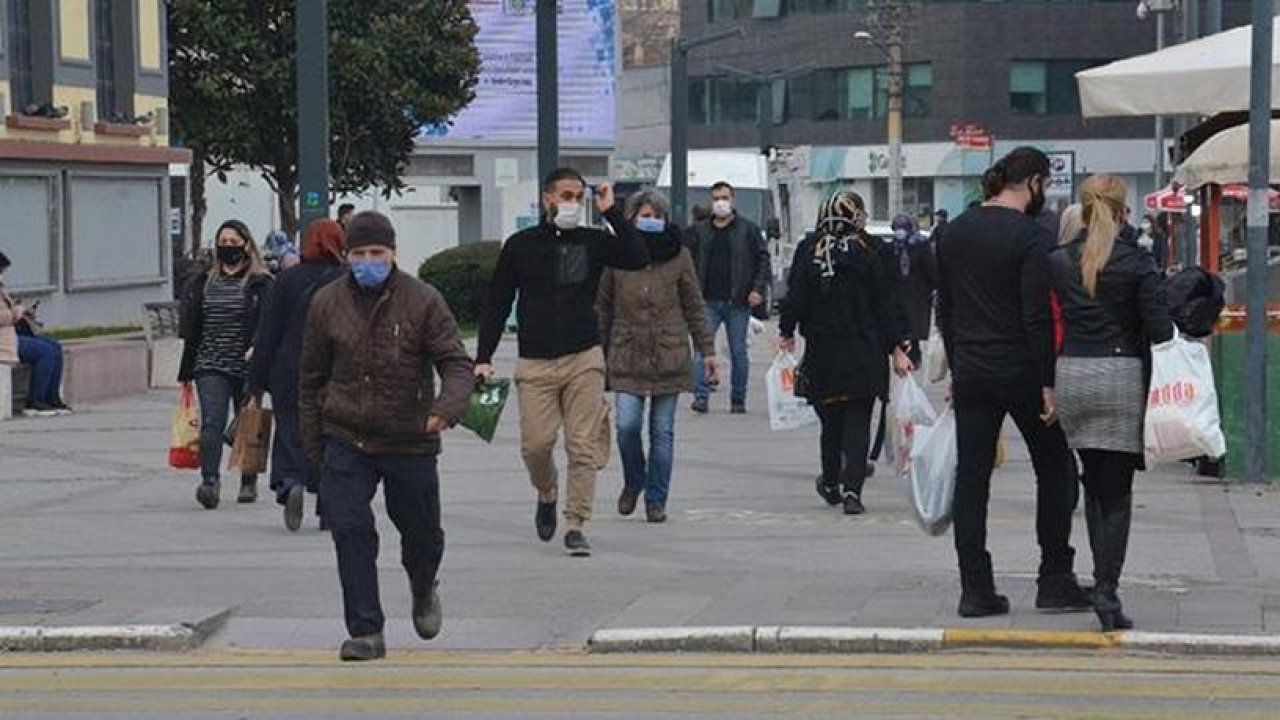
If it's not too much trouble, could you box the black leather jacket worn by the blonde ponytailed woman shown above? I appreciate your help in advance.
[1050,227,1174,357]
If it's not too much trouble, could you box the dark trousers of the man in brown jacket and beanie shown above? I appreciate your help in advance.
[320,439,444,638]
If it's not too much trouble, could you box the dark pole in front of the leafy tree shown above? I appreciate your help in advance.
[296,0,329,237]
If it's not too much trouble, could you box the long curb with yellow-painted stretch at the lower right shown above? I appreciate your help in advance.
[588,625,1280,657]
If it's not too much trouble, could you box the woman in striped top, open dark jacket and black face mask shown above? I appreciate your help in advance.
[178,220,271,510]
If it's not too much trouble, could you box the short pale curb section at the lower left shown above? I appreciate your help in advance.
[0,607,236,652]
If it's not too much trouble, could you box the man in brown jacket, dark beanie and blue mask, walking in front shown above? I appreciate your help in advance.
[298,213,474,660]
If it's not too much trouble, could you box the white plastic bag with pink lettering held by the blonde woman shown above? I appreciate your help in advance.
[1142,333,1226,468]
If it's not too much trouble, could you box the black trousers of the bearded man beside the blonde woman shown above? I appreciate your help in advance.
[952,380,1079,592]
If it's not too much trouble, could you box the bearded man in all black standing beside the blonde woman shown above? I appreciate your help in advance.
[938,147,1091,618]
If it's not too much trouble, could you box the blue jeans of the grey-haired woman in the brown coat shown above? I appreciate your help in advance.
[616,392,680,507]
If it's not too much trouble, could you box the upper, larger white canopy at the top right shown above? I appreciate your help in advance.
[1075,17,1280,118]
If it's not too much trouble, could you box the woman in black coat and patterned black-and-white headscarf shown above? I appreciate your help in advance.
[780,192,913,515]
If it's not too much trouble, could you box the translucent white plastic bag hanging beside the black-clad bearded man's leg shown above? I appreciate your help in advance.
[910,407,959,536]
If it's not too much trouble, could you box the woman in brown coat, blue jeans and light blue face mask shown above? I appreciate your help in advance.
[595,191,716,523]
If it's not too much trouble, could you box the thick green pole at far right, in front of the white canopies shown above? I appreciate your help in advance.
[1244,0,1275,483]
